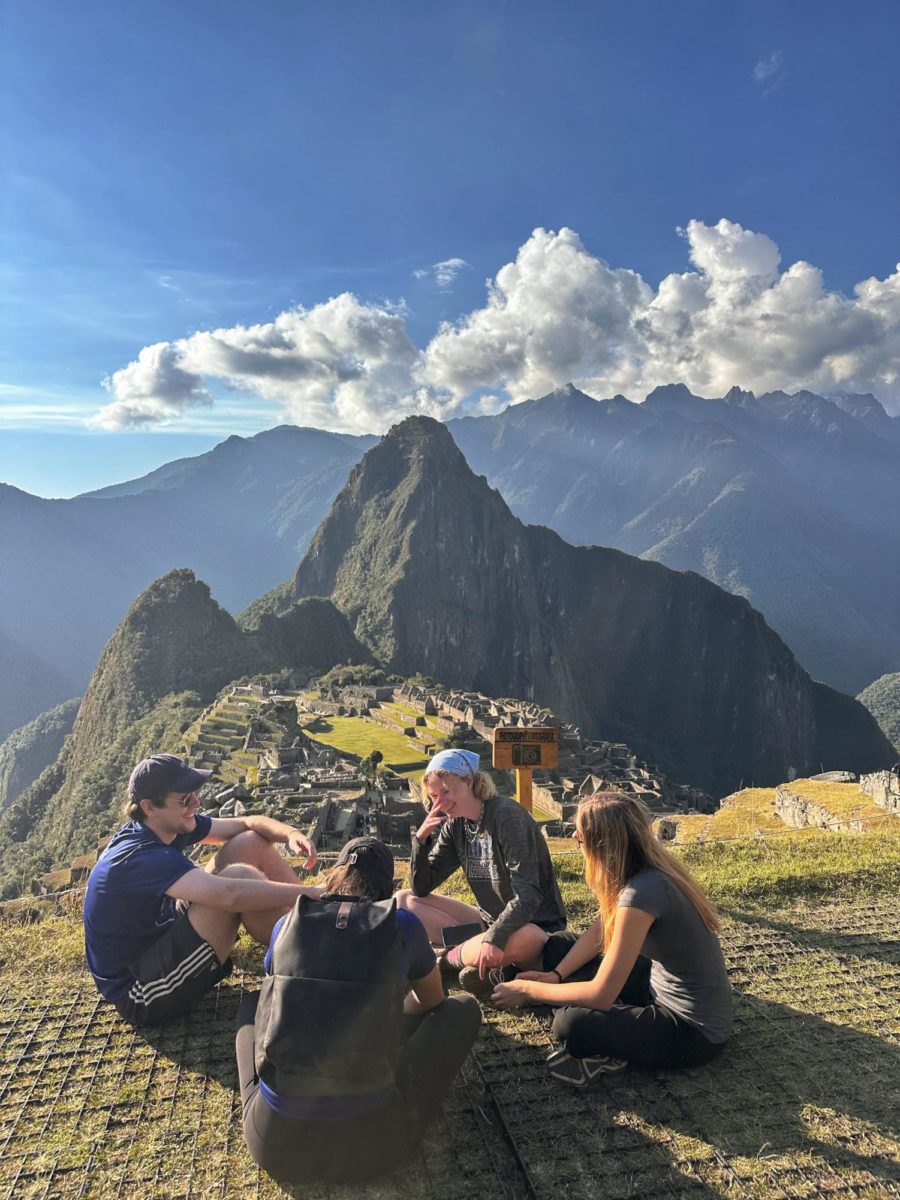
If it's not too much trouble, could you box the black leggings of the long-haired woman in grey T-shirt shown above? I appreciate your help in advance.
[544,934,724,1067]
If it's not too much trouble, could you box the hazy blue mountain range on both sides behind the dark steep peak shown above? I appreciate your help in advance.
[0,385,900,738]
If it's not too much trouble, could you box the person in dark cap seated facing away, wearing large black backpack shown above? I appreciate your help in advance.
[235,838,481,1183]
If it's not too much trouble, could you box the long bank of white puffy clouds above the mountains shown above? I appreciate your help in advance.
[94,220,900,432]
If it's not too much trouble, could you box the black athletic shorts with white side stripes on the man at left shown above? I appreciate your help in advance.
[115,912,232,1025]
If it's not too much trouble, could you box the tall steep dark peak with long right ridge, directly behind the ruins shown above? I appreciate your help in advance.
[283,415,893,794]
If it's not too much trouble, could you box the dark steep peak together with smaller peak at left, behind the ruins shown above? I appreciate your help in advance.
[0,416,895,892]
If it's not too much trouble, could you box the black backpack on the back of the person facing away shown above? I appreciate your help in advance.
[256,895,404,1097]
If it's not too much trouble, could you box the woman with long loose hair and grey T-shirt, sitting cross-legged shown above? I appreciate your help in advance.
[493,792,732,1087]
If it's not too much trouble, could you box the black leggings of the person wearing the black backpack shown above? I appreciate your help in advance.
[236,992,481,1183]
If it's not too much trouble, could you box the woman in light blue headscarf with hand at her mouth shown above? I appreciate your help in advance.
[397,750,565,1000]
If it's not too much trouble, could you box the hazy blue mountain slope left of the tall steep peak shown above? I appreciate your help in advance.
[0,426,376,740]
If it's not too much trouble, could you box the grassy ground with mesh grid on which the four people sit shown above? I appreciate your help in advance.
[0,833,900,1200]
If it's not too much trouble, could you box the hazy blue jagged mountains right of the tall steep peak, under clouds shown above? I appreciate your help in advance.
[448,384,900,692]
